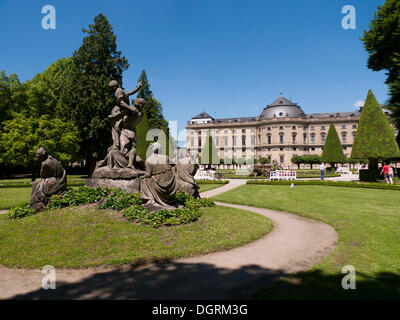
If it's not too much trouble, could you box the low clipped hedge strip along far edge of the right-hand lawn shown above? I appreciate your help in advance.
[246,180,400,190]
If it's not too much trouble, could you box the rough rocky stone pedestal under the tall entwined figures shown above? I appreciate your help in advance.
[86,167,145,193]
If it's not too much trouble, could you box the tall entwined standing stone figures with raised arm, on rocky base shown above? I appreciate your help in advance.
[86,80,145,192]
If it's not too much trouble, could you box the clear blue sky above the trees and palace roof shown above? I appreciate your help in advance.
[0,0,387,144]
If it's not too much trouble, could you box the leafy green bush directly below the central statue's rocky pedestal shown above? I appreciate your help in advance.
[99,188,142,211]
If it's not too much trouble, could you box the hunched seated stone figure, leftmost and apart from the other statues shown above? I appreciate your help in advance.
[30,148,67,211]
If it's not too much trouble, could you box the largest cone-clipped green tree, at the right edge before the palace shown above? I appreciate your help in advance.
[351,90,400,169]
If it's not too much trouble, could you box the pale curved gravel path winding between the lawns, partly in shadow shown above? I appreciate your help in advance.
[0,179,337,299]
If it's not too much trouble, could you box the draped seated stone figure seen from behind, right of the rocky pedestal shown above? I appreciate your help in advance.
[139,142,178,211]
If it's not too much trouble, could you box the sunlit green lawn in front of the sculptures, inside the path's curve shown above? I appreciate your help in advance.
[0,206,272,268]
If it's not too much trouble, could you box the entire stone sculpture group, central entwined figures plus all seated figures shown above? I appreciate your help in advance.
[30,80,200,211]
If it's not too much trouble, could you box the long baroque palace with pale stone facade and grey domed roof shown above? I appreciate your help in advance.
[186,96,389,168]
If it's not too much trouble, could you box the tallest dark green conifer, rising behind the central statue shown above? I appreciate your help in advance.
[60,14,129,173]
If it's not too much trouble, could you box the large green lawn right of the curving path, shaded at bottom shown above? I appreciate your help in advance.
[214,185,400,299]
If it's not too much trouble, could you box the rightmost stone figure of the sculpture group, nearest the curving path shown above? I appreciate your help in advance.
[176,150,200,198]
